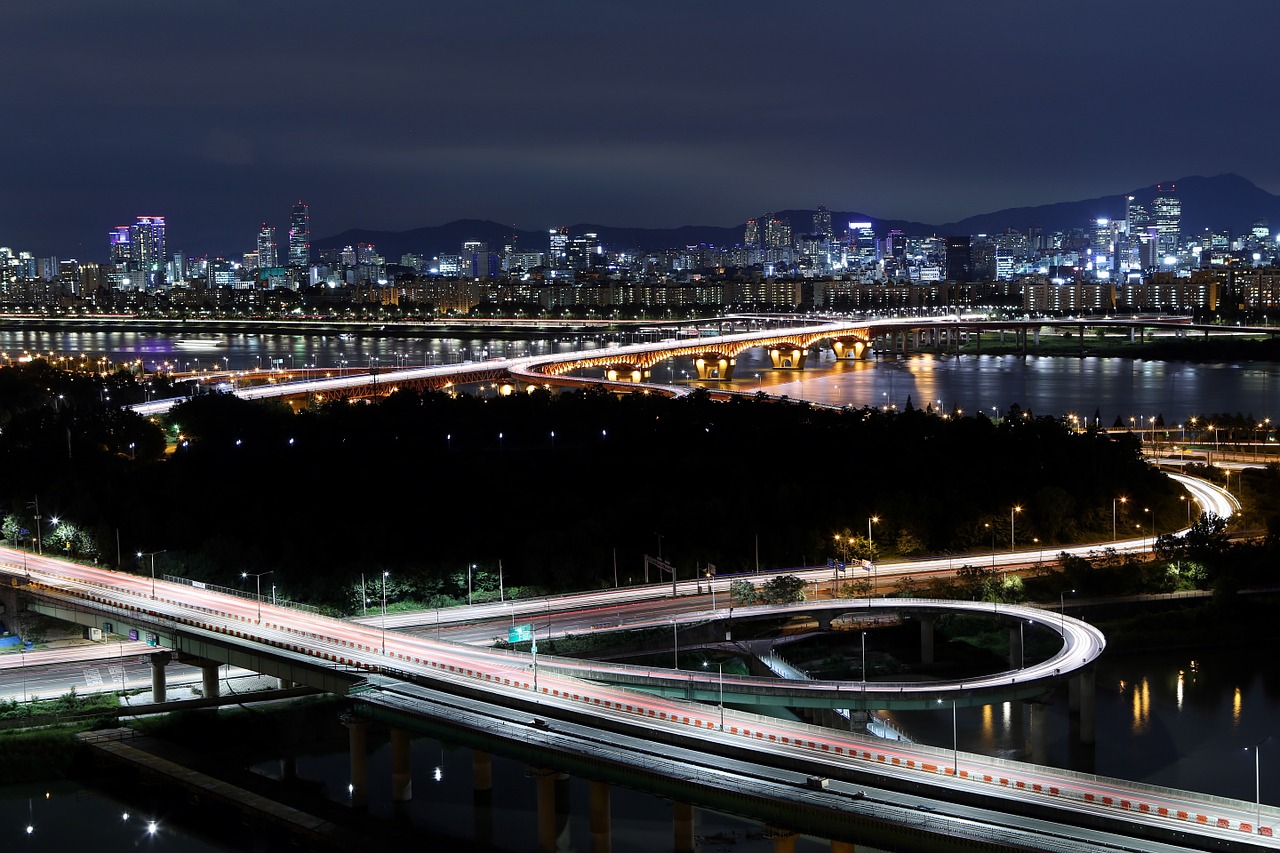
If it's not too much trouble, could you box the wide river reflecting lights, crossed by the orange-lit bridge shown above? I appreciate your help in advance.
[0,330,1280,417]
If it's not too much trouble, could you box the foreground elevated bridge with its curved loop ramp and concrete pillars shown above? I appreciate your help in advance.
[0,517,1280,849]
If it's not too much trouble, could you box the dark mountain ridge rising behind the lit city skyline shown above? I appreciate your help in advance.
[315,174,1280,263]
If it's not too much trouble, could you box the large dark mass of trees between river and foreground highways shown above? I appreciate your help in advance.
[0,365,1185,608]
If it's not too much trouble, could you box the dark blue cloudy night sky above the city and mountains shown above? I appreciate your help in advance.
[0,0,1280,260]
